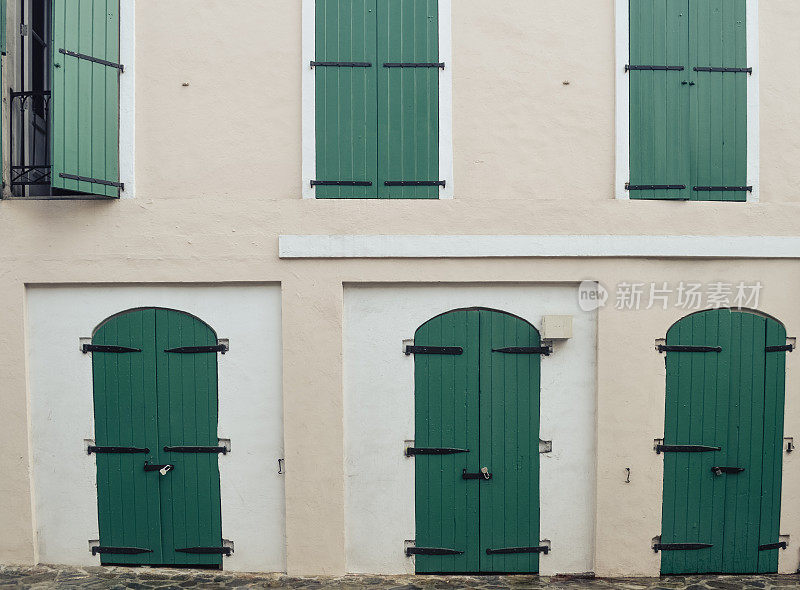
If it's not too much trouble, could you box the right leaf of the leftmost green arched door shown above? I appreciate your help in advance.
[156,310,222,565]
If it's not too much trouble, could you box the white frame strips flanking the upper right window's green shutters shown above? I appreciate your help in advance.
[614,0,760,203]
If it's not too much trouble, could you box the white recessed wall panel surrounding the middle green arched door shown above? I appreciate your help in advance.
[344,284,597,575]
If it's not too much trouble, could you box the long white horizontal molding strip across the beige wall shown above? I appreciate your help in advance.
[278,235,800,258]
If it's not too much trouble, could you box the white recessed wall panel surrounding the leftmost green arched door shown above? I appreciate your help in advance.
[27,285,286,572]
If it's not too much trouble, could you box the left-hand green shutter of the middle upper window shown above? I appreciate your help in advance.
[315,0,378,199]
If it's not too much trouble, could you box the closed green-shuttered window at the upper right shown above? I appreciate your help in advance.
[618,0,757,201]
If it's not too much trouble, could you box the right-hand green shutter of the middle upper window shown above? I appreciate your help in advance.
[377,0,441,199]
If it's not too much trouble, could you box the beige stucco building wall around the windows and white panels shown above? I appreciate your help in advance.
[0,0,800,575]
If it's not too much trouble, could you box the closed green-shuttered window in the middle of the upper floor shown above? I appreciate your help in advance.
[304,0,452,199]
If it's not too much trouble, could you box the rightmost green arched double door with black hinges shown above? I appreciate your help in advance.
[660,309,787,574]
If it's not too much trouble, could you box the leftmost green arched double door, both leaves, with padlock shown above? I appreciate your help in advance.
[87,309,224,565]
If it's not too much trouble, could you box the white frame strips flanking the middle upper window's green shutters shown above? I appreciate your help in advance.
[302,0,454,199]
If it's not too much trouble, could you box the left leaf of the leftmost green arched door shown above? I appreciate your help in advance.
[92,310,161,564]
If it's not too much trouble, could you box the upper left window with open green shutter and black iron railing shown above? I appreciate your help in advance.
[7,0,124,198]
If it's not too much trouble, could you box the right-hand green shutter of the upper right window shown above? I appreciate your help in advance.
[689,0,748,201]
